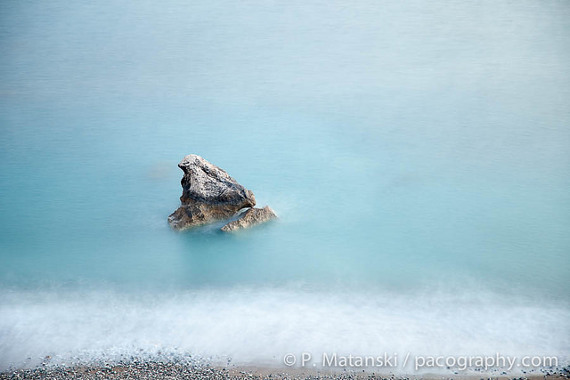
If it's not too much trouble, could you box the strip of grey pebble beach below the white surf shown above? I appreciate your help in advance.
[0,361,570,380]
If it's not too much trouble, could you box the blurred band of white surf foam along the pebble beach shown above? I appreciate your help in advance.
[0,288,570,369]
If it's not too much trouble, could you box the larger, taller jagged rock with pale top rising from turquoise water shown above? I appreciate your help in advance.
[168,154,255,230]
